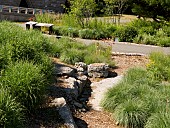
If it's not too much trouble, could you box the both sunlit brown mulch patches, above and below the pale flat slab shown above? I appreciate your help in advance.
[77,55,149,128]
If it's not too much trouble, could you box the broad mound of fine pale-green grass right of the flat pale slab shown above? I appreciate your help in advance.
[101,68,170,128]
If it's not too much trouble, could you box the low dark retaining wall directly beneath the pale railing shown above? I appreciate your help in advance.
[0,12,34,22]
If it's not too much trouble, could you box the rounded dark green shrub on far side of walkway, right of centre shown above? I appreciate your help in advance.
[114,26,138,42]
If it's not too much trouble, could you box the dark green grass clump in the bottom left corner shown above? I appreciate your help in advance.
[0,87,24,128]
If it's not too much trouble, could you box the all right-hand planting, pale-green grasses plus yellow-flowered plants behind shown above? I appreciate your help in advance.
[101,53,170,128]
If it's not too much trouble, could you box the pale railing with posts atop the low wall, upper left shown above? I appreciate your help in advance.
[0,5,53,15]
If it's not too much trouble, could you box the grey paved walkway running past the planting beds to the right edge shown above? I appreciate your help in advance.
[76,38,170,55]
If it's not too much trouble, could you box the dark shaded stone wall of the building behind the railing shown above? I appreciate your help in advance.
[0,0,66,12]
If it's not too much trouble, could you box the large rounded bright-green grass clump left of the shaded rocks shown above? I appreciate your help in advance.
[1,61,46,110]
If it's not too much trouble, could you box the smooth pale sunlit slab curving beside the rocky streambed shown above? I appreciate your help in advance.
[89,75,123,111]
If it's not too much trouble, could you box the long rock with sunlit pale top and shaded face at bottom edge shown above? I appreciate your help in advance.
[51,97,77,128]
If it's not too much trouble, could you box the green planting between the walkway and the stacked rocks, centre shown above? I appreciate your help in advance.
[52,38,115,66]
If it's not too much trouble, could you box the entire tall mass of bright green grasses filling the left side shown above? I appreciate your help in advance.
[0,21,56,128]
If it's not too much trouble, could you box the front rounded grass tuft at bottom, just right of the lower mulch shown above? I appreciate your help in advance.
[114,99,149,128]
